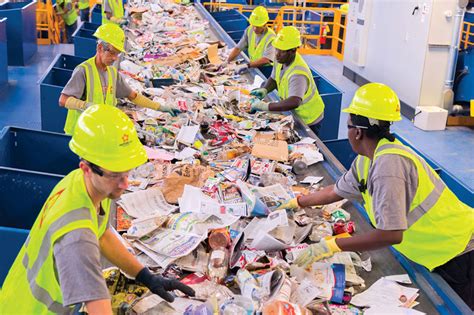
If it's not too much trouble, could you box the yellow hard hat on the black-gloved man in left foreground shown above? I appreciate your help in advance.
[69,105,147,172]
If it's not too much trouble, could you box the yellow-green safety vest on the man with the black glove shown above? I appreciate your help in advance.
[0,169,111,314]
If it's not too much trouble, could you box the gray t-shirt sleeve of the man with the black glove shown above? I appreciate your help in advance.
[54,216,110,306]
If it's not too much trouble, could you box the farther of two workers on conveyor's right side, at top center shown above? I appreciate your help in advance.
[227,6,275,74]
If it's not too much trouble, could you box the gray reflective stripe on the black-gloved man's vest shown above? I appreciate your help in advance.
[22,208,91,314]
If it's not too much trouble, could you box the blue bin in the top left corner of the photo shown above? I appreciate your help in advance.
[0,1,38,66]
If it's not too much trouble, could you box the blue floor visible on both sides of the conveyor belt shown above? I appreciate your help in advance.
[0,44,474,190]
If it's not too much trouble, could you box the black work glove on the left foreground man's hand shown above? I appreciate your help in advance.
[135,267,196,303]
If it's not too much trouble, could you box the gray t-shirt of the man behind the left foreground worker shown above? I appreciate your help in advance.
[61,66,133,100]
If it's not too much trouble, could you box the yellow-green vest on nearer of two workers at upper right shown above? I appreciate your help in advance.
[275,53,324,124]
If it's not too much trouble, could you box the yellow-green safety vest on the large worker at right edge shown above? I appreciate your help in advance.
[355,139,474,270]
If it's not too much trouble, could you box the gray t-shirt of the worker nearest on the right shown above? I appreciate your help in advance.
[334,154,418,230]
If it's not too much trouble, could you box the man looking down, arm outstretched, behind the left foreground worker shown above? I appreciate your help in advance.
[59,23,179,135]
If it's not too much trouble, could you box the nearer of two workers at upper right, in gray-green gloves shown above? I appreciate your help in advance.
[250,26,324,135]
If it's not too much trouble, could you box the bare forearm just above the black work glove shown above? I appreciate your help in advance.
[99,228,144,277]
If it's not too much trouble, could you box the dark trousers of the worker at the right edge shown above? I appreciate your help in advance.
[433,251,474,310]
